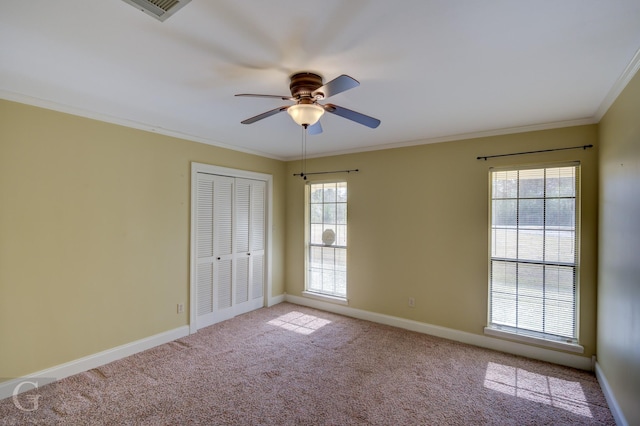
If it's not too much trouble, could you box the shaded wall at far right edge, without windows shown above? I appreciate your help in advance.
[598,70,640,425]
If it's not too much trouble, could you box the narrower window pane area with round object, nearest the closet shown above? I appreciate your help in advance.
[306,182,347,299]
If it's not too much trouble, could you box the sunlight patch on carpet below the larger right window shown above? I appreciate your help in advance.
[484,362,593,418]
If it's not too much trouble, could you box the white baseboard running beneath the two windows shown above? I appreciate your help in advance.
[285,294,593,371]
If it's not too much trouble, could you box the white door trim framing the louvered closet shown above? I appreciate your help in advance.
[189,162,276,334]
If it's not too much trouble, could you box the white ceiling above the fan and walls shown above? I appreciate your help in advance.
[0,0,640,159]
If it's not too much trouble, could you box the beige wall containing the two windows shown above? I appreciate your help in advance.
[286,125,598,357]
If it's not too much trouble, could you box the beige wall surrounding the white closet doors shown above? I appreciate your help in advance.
[0,101,285,380]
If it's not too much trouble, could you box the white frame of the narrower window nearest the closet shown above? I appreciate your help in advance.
[302,179,349,305]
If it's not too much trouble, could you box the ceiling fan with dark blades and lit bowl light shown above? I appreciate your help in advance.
[236,72,380,135]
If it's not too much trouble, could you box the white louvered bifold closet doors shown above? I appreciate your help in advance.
[195,173,266,328]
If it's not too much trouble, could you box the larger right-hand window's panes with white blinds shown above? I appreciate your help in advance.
[488,164,580,344]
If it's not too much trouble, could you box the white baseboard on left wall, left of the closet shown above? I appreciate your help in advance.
[0,325,189,399]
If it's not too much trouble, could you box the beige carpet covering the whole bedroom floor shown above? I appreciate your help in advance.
[0,303,615,425]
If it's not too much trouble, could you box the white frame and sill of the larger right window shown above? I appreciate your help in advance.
[484,161,584,353]
